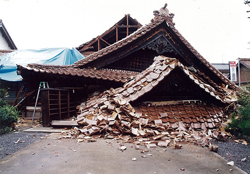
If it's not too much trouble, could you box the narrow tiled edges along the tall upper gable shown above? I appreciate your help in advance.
[73,16,237,89]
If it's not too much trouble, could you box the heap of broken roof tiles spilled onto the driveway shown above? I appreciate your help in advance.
[61,89,228,151]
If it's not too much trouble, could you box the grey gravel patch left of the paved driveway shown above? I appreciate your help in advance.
[0,131,47,160]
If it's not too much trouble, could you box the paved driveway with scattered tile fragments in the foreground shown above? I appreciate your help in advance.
[0,134,244,174]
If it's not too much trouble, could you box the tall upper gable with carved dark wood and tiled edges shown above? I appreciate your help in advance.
[73,8,237,89]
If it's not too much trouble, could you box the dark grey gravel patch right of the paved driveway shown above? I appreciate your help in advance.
[212,139,250,174]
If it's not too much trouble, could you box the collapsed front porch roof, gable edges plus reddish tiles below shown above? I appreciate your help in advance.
[78,56,236,130]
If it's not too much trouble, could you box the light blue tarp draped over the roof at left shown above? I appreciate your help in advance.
[0,48,84,81]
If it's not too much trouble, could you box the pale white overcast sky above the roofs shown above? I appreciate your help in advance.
[0,0,250,63]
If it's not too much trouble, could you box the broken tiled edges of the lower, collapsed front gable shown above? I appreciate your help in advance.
[83,56,237,112]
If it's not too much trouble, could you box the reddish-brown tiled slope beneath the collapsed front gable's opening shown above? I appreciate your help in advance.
[135,102,227,130]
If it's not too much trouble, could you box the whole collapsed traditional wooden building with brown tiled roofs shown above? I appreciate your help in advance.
[18,3,237,140]
